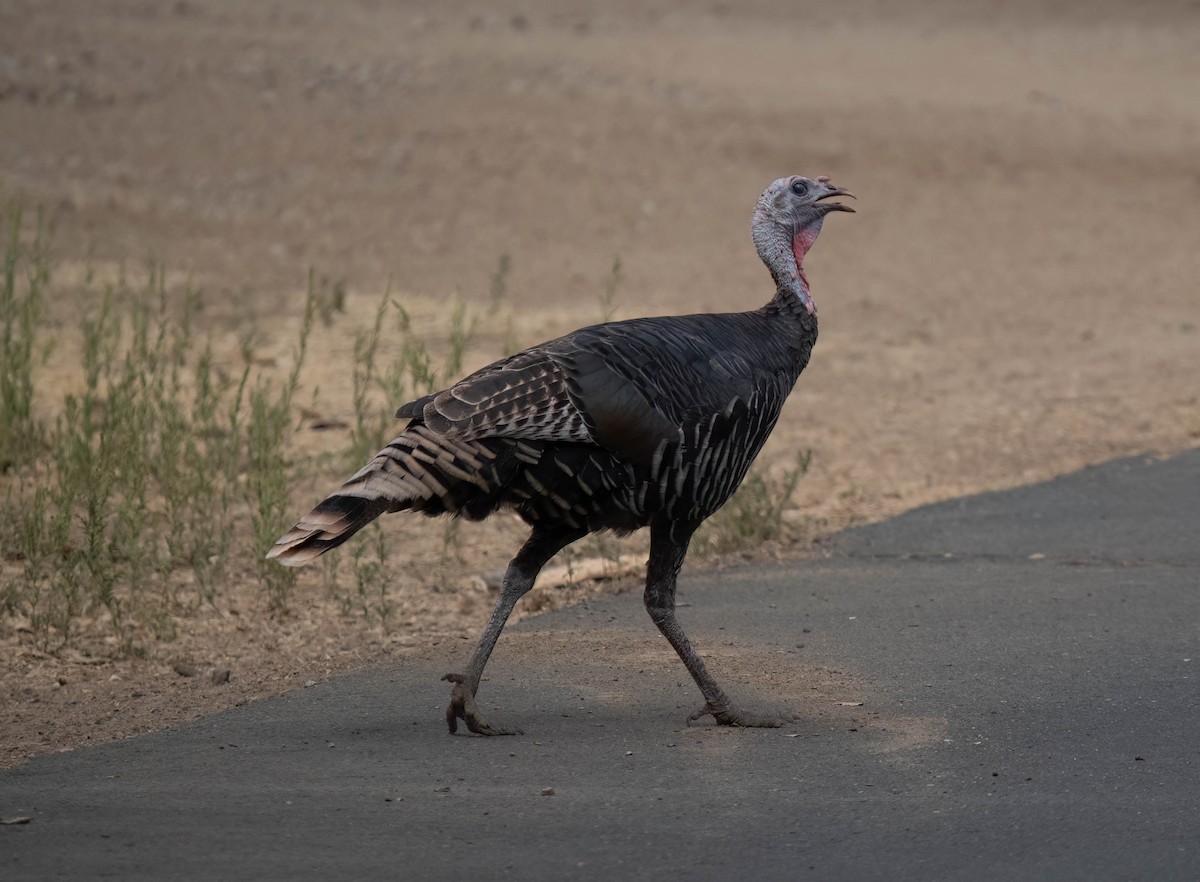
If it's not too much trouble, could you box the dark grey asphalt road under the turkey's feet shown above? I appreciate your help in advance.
[0,451,1200,882]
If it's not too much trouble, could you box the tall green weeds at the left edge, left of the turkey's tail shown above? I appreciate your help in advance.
[0,210,314,654]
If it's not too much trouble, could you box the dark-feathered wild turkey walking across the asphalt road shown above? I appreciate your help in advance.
[268,176,853,734]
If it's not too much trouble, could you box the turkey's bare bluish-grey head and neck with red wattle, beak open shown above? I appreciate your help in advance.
[750,175,854,314]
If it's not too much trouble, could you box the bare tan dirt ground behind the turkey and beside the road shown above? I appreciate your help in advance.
[0,0,1200,767]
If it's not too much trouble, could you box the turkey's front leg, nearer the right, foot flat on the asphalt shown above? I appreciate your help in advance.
[644,523,784,727]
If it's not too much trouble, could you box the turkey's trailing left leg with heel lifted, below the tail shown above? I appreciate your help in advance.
[442,527,587,734]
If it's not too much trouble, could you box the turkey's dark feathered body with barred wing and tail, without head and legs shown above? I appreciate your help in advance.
[289,305,816,556]
